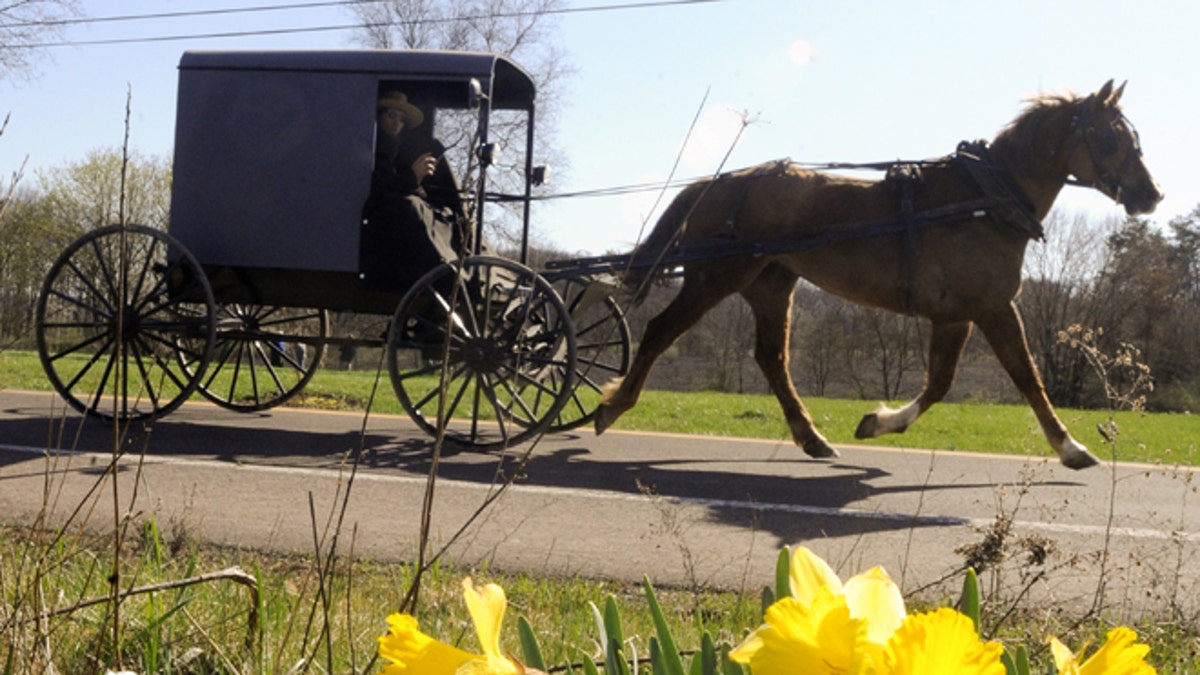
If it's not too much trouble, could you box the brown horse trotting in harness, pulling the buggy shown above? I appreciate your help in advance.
[595,80,1163,468]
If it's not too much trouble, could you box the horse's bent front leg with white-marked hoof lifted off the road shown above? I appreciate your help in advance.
[854,321,971,438]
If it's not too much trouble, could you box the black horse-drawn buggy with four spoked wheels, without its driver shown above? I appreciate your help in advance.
[37,50,630,446]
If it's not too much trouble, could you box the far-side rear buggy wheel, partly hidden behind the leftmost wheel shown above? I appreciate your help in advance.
[179,304,329,412]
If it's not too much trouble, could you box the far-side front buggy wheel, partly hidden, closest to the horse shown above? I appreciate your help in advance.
[535,276,632,432]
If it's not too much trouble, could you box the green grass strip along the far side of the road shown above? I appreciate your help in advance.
[0,351,1200,465]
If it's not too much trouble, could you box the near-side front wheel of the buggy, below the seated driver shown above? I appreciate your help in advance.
[388,256,576,447]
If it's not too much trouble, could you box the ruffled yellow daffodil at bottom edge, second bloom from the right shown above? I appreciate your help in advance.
[880,607,1004,675]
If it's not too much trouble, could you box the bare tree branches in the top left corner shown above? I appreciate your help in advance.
[0,0,80,79]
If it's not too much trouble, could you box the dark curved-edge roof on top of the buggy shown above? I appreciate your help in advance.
[179,49,536,109]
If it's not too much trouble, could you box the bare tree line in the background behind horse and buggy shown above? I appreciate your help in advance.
[7,149,1200,411]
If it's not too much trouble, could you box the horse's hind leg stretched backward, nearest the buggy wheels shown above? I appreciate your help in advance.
[595,269,737,435]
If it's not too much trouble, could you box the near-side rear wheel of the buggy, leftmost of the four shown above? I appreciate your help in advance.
[37,225,216,420]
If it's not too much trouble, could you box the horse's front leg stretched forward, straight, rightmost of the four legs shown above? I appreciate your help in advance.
[976,303,1099,468]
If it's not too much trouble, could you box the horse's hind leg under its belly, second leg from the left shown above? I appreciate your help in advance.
[742,267,838,458]
